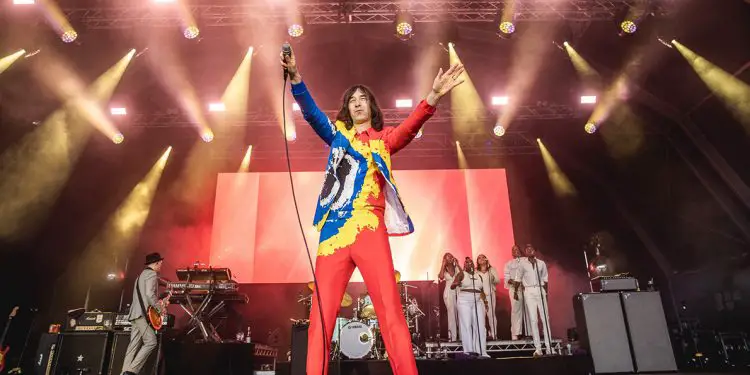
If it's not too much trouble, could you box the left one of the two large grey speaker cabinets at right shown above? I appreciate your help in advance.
[573,293,633,374]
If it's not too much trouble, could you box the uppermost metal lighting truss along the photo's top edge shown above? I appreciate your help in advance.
[62,0,676,29]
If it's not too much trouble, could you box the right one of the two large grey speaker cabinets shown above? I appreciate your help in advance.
[622,292,677,372]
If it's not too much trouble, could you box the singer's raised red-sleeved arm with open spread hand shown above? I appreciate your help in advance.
[383,64,464,154]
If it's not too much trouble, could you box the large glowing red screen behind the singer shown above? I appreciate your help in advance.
[210,169,514,283]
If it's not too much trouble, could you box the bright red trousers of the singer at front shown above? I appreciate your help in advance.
[307,217,417,375]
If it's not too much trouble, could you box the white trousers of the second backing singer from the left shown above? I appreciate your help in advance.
[458,292,487,356]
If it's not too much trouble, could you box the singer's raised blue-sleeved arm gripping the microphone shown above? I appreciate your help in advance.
[281,44,336,145]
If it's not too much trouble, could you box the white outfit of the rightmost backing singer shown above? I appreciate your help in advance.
[515,258,552,354]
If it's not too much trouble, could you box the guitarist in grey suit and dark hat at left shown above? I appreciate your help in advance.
[122,253,166,375]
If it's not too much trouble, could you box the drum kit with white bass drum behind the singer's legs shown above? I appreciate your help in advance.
[298,271,425,359]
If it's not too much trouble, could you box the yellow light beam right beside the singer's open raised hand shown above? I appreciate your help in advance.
[448,43,484,134]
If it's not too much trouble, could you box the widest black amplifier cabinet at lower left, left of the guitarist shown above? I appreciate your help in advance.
[54,332,112,375]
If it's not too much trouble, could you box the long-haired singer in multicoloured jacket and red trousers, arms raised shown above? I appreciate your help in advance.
[281,44,464,375]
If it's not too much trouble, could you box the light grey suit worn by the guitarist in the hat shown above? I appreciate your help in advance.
[122,268,160,374]
